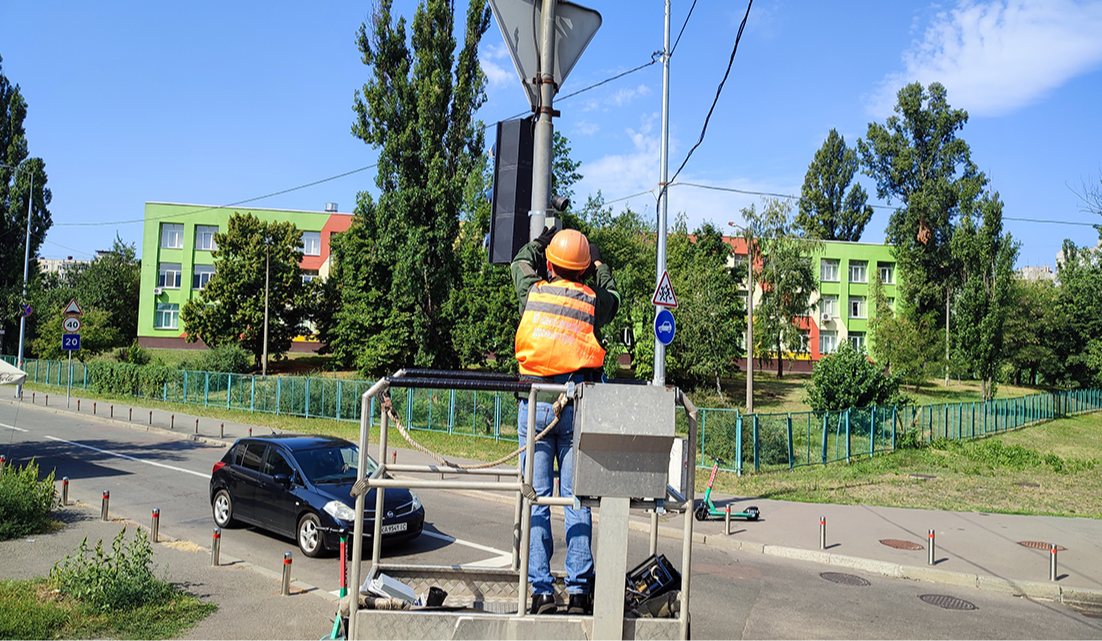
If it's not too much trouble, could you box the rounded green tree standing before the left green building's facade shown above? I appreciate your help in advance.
[180,214,310,367]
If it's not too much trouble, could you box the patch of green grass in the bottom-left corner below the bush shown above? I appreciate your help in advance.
[0,578,217,641]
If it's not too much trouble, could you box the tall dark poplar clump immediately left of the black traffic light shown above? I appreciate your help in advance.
[318,0,490,376]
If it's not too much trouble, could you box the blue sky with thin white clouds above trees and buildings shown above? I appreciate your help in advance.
[0,0,1102,264]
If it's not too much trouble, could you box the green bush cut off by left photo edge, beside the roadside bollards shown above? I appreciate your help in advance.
[0,460,58,541]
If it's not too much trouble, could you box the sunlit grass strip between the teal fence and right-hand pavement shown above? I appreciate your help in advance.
[714,414,1102,519]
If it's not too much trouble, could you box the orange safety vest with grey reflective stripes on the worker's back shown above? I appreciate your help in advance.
[516,280,605,377]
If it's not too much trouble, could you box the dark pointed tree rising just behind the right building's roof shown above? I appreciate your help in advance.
[796,129,873,242]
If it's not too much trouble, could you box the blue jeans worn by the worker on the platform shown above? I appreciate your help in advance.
[517,400,593,595]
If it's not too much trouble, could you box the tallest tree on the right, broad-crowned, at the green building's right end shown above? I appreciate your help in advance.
[857,83,986,327]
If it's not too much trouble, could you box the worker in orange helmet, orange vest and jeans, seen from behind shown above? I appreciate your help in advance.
[511,229,620,615]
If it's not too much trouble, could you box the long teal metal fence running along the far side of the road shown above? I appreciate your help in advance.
[10,356,1102,474]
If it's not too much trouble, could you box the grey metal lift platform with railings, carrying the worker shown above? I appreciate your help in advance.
[347,370,698,641]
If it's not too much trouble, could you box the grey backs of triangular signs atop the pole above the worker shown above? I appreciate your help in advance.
[489,0,601,109]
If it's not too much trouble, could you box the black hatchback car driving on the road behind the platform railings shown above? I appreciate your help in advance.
[210,434,424,556]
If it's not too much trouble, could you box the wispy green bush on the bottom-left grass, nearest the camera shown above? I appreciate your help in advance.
[50,525,175,612]
